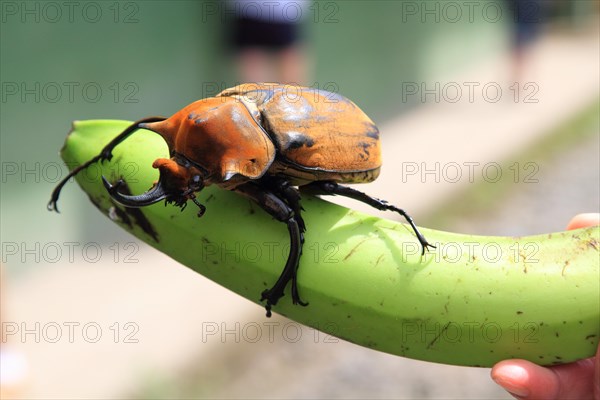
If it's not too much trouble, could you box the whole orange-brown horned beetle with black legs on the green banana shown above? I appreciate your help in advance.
[48,83,434,317]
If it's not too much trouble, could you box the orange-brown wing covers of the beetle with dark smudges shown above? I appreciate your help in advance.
[218,84,381,178]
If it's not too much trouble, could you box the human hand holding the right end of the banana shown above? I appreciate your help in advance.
[491,214,600,400]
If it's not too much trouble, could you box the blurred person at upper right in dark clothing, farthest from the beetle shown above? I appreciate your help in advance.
[505,0,543,82]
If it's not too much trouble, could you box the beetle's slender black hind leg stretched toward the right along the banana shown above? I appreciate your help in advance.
[302,181,435,255]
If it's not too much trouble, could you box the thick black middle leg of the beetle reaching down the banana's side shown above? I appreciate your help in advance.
[234,182,308,317]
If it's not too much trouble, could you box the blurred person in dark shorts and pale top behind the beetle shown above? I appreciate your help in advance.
[224,0,310,85]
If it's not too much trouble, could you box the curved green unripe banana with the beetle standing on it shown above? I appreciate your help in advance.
[54,120,600,367]
